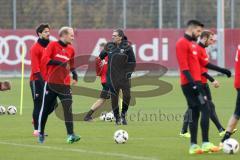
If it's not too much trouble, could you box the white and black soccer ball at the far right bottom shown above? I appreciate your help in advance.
[223,138,239,154]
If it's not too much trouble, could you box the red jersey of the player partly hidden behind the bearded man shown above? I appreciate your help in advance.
[198,45,209,84]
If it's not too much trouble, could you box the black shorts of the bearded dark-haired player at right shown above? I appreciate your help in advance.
[181,83,206,108]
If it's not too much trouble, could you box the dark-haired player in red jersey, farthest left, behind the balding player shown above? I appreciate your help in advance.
[30,23,50,136]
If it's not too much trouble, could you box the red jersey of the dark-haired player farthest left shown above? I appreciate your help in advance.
[30,42,47,81]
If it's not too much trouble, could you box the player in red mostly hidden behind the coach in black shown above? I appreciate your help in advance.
[84,43,110,121]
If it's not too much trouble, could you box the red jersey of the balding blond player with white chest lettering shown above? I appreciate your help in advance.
[42,41,75,85]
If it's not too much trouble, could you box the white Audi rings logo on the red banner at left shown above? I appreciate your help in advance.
[0,35,57,65]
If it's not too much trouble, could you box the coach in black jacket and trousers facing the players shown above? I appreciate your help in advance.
[99,29,136,125]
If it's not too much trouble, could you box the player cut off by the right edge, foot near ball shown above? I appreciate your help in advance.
[220,46,240,145]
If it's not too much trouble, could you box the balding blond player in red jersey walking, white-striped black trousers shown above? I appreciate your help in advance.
[38,27,80,143]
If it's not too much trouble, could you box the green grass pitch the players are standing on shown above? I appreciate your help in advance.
[0,77,240,160]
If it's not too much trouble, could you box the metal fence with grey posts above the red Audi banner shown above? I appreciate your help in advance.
[0,0,240,29]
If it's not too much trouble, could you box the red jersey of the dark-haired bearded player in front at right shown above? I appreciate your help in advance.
[176,35,201,85]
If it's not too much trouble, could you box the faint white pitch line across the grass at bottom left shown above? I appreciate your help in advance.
[0,141,159,160]
